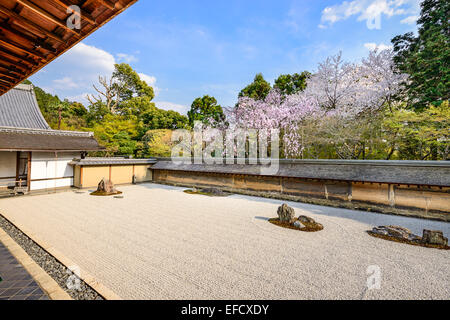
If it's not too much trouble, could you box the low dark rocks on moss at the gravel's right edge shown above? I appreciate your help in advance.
[369,226,450,250]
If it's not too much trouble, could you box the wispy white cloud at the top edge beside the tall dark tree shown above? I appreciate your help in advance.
[319,0,423,29]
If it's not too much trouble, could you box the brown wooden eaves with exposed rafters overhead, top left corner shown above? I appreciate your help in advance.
[0,0,137,95]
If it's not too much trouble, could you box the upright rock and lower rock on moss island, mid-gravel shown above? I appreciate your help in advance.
[269,204,324,232]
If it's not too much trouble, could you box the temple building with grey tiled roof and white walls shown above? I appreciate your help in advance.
[0,84,102,192]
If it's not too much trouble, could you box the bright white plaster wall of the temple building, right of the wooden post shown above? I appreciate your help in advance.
[30,152,81,191]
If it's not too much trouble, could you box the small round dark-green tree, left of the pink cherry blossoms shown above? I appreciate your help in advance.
[188,96,225,127]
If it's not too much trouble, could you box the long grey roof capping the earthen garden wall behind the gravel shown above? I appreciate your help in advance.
[152,159,450,187]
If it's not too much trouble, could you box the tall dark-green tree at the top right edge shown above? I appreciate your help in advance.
[392,0,450,111]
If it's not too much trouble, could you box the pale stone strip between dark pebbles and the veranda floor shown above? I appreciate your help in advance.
[0,229,73,300]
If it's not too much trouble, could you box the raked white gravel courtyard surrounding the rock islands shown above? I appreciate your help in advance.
[0,184,450,299]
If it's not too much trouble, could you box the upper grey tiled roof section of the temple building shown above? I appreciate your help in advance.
[0,84,50,129]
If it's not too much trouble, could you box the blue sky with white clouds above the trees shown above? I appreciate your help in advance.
[30,0,420,113]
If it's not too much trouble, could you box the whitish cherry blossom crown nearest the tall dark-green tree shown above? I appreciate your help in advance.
[305,50,407,118]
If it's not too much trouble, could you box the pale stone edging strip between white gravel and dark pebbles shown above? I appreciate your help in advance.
[0,215,123,300]
